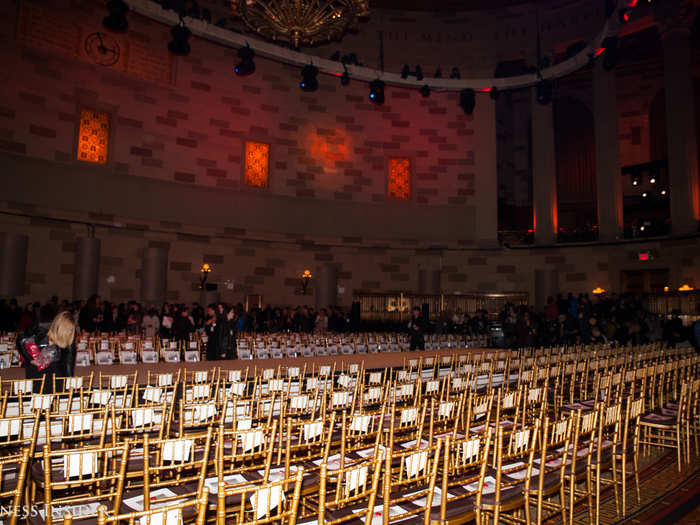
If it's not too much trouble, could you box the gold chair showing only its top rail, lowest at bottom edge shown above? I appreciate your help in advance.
[95,489,209,525]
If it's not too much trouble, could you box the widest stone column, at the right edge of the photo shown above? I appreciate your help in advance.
[654,0,700,235]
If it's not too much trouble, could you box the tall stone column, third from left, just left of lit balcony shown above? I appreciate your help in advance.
[593,60,624,241]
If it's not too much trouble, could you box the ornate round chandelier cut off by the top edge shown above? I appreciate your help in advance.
[231,0,369,48]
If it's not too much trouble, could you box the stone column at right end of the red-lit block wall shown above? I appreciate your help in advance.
[473,94,498,247]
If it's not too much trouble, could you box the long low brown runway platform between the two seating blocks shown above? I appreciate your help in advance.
[0,348,508,384]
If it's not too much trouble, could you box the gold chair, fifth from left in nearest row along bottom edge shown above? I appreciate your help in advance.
[430,428,495,525]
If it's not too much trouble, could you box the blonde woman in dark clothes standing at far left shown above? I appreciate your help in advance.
[17,311,75,394]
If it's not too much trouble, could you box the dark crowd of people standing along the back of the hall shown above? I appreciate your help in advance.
[0,293,700,352]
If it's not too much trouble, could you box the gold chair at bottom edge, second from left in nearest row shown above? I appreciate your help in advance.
[210,468,304,525]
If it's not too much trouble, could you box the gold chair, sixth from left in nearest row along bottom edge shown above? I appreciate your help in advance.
[476,420,540,524]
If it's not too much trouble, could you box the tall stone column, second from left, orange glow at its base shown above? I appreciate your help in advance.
[530,87,558,244]
